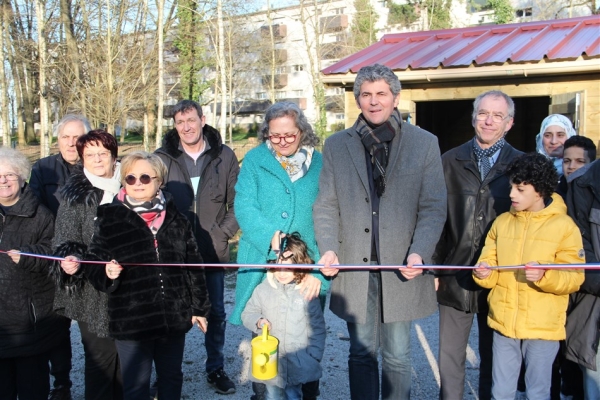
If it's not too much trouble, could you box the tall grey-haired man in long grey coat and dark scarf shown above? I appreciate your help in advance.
[313,64,446,399]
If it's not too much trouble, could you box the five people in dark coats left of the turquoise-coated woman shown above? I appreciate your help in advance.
[0,101,239,400]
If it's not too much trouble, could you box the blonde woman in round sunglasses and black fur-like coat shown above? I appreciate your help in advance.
[85,151,210,400]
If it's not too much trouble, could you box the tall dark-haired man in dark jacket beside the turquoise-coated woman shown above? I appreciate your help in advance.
[156,100,239,394]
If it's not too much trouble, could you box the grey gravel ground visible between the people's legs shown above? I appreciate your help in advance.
[64,272,479,400]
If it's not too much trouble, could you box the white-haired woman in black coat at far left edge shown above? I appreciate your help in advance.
[0,148,61,400]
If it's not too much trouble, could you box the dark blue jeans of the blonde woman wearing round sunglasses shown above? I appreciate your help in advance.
[115,333,185,400]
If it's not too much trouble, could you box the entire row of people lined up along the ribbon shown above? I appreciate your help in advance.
[0,64,600,400]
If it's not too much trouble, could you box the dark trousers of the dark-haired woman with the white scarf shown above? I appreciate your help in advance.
[79,322,123,400]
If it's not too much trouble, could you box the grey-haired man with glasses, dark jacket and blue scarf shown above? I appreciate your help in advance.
[433,91,521,400]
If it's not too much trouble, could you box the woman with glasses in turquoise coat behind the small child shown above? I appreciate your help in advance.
[230,102,329,399]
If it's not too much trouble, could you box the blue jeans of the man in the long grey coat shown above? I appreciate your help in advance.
[347,272,412,400]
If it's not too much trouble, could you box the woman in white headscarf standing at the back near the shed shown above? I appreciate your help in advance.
[535,114,577,176]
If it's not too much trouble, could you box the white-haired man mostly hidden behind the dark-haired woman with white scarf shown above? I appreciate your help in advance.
[29,114,91,400]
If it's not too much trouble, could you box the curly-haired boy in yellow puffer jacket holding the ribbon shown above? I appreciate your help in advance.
[473,153,585,400]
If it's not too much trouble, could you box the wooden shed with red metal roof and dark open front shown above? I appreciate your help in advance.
[322,15,600,151]
